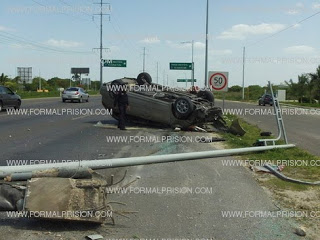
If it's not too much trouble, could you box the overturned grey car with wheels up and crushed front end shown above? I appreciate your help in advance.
[100,73,242,131]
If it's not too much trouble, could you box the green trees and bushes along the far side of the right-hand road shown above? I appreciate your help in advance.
[215,66,320,107]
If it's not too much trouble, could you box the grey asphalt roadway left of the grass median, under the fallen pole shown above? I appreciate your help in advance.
[0,97,306,240]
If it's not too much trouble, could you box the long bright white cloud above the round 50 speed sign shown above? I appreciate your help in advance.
[218,23,286,40]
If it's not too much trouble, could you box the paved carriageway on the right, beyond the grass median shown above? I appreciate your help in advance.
[217,101,320,156]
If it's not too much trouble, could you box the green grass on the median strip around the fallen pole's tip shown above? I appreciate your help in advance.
[224,115,320,190]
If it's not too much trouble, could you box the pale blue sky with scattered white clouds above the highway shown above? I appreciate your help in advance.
[0,0,320,86]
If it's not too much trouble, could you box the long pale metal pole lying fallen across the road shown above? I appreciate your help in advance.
[0,144,295,178]
